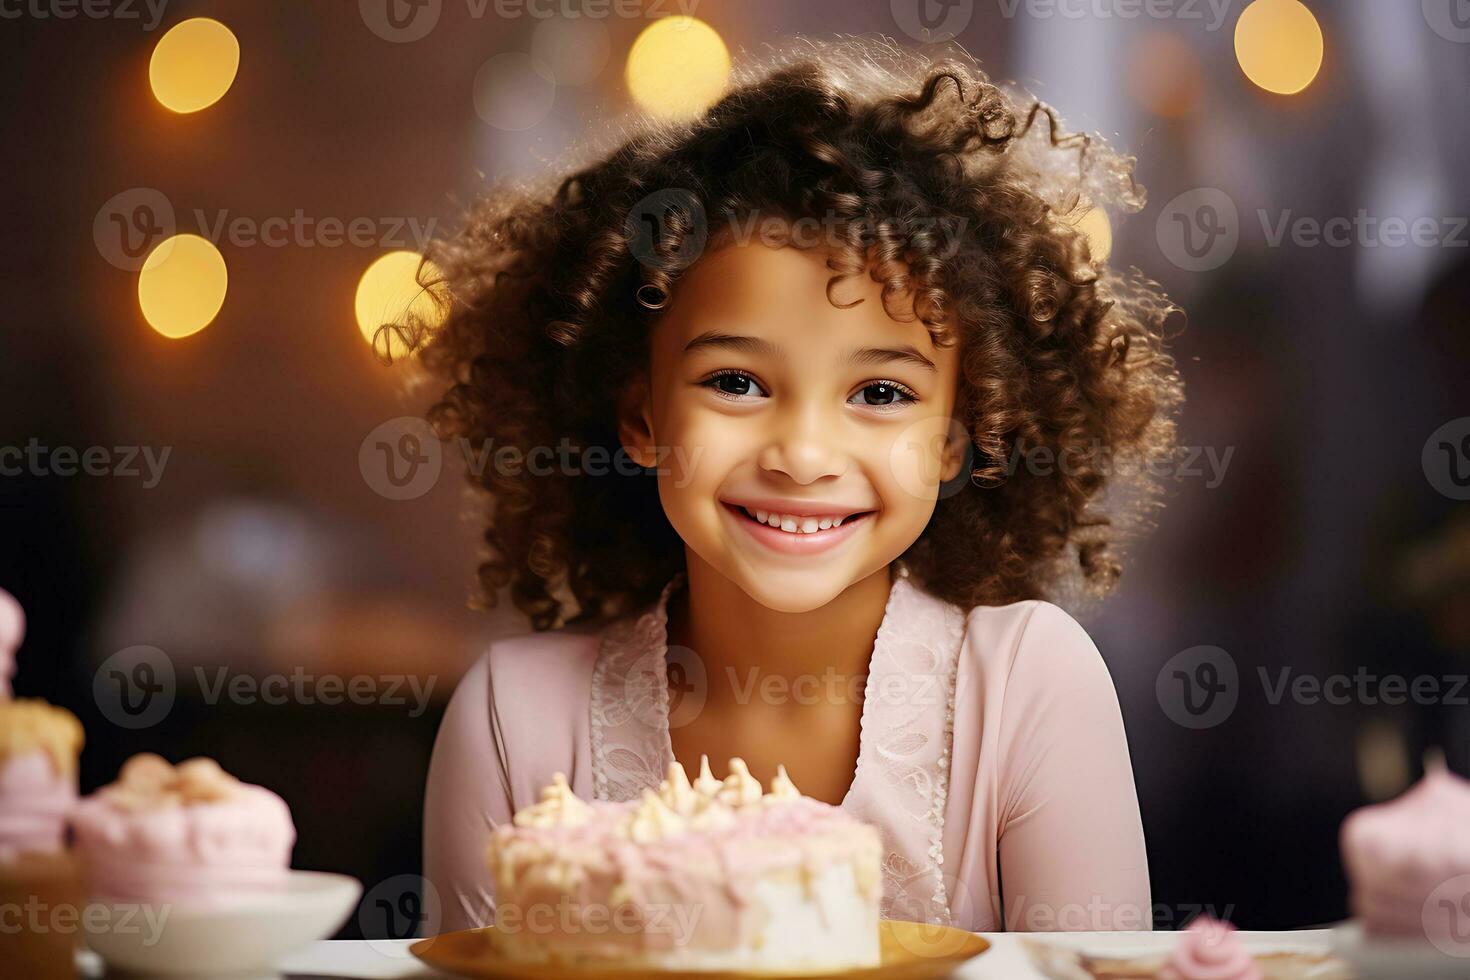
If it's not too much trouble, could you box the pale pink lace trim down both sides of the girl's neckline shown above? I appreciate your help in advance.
[591,563,966,926]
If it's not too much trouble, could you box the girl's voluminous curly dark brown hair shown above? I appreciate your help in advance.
[384,38,1182,630]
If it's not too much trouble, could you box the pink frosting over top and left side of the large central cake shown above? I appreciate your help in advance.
[490,798,882,956]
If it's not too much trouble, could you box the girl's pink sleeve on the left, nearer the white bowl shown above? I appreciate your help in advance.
[423,652,515,932]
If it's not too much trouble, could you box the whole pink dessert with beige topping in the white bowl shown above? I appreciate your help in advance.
[74,752,295,908]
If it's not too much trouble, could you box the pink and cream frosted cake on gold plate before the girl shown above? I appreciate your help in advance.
[487,757,882,971]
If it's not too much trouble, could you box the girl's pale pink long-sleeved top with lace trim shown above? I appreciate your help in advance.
[423,564,1151,932]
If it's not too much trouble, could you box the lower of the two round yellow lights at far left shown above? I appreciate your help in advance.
[138,235,229,339]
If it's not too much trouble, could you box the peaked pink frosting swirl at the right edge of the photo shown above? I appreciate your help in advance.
[1339,763,1470,936]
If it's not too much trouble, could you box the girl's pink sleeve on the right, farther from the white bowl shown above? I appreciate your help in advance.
[997,602,1152,932]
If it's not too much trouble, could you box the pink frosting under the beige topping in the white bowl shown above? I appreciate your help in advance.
[74,783,295,907]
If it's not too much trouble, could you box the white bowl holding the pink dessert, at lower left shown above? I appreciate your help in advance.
[84,871,363,977]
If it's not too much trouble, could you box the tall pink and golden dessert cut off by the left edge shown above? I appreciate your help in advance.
[0,591,85,979]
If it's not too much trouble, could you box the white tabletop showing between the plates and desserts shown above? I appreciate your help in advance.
[84,929,1346,980]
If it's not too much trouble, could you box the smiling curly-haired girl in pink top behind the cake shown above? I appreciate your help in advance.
[420,41,1180,930]
